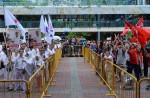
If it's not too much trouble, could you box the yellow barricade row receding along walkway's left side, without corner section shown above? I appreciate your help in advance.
[29,49,62,98]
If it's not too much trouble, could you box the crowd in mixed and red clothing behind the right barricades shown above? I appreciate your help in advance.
[83,36,150,89]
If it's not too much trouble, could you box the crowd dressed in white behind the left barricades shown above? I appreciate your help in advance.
[0,38,61,91]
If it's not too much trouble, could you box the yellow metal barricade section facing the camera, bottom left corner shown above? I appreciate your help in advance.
[0,80,29,98]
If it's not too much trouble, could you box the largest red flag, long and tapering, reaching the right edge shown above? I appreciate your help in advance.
[122,18,150,47]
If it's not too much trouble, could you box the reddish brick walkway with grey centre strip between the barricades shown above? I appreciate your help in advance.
[47,57,114,98]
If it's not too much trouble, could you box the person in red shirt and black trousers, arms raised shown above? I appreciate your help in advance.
[128,43,140,80]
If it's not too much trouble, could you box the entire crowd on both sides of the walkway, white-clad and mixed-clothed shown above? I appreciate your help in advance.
[0,33,150,91]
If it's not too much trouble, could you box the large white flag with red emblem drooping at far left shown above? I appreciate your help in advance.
[4,8,26,42]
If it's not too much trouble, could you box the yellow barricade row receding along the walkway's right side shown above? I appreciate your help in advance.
[84,47,138,98]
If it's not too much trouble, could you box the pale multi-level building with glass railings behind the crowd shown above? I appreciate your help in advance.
[0,0,150,39]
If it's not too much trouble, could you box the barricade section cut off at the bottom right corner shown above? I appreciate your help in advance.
[138,78,150,98]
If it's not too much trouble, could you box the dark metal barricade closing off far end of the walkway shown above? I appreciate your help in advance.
[63,45,84,57]
